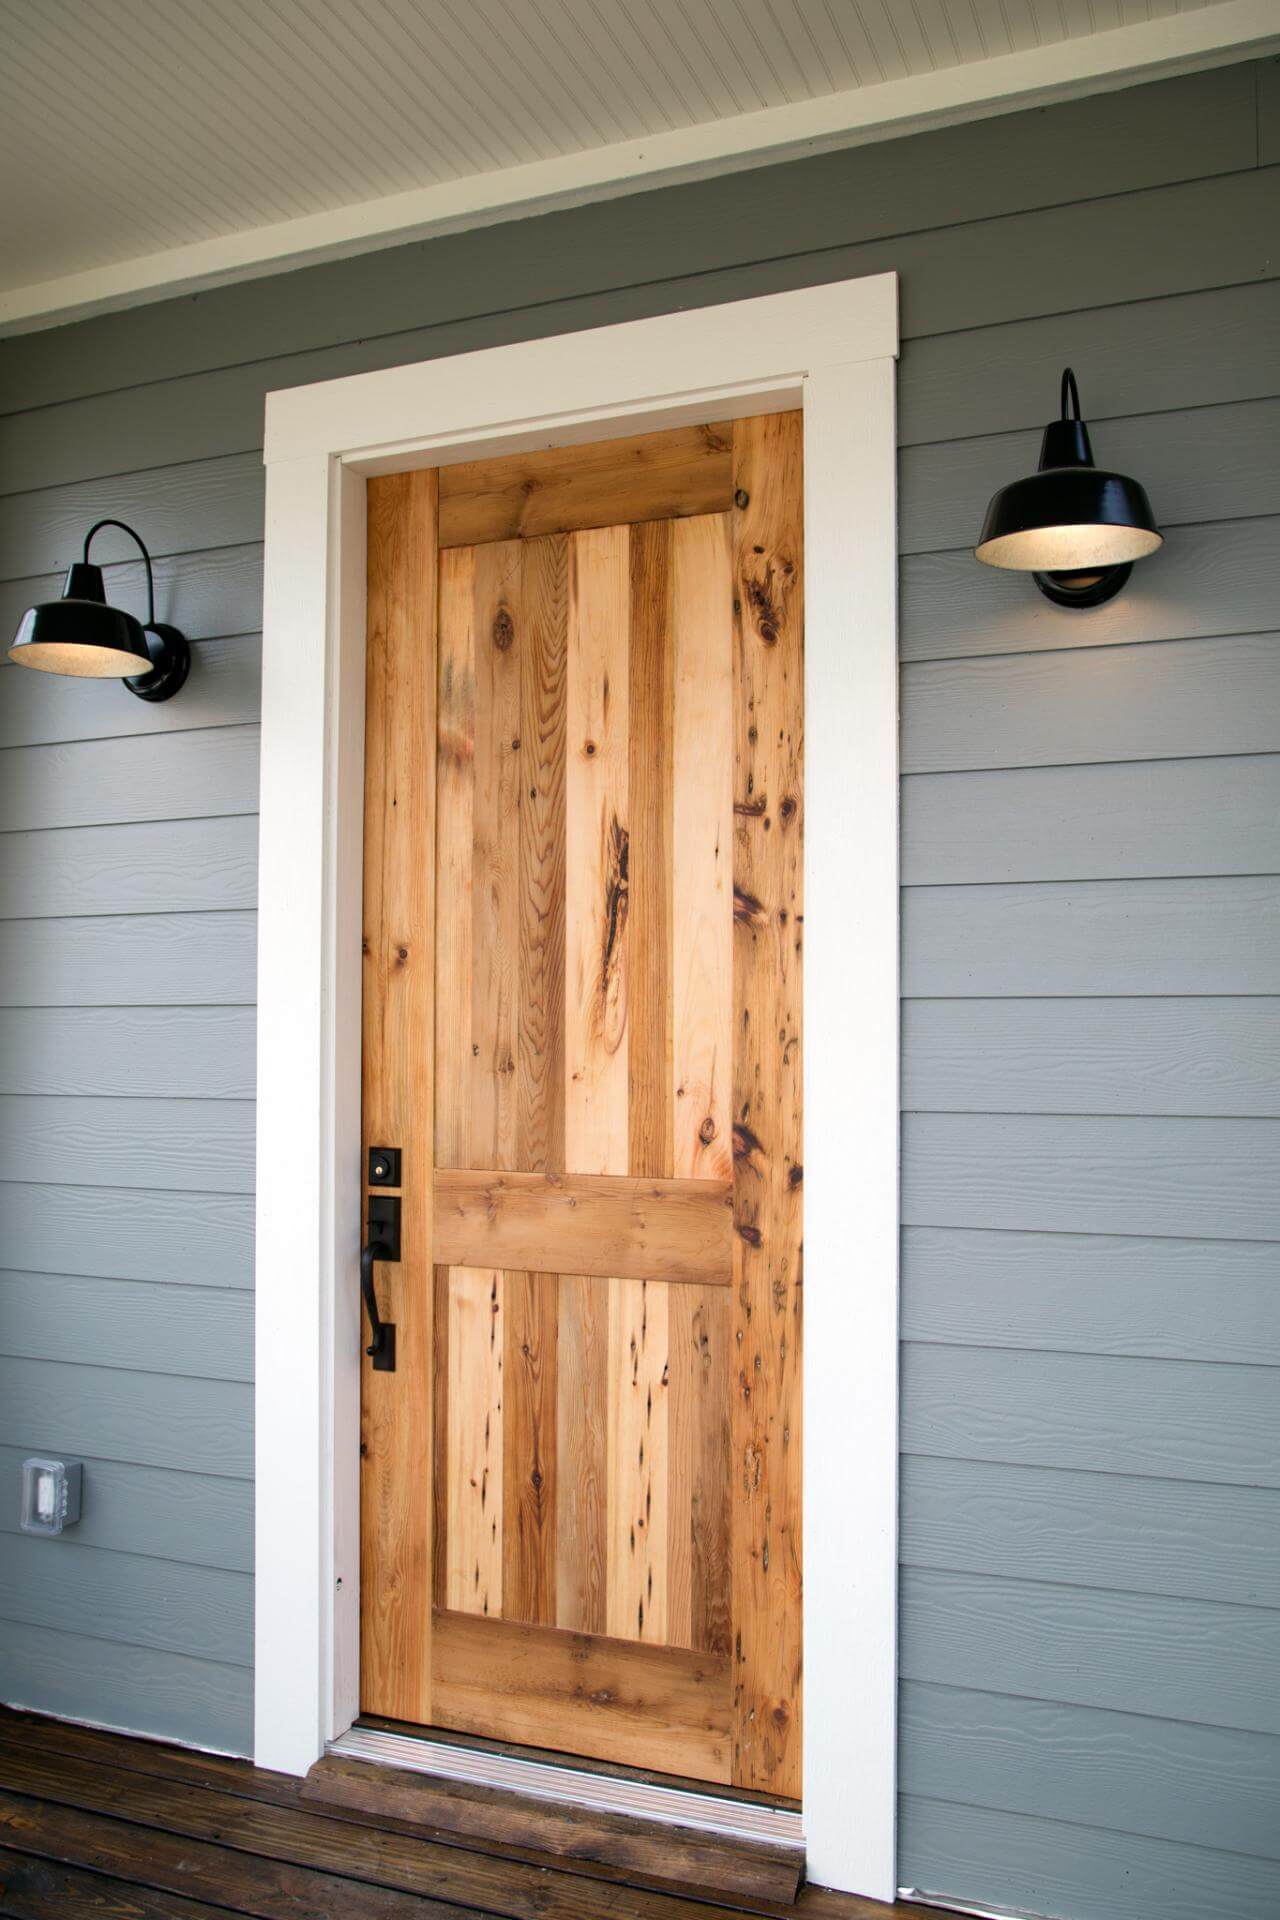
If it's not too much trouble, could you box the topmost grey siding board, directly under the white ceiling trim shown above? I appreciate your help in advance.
[0,67,1255,407]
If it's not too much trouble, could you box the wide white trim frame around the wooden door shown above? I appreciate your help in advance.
[255,275,898,1901]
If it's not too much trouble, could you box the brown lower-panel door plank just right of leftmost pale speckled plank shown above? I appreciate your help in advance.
[503,1271,560,1626]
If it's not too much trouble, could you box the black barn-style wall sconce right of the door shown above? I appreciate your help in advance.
[975,367,1165,607]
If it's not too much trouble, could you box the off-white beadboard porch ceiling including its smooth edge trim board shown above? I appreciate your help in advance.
[0,0,1280,326]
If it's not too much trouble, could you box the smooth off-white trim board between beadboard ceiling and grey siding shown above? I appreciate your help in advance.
[0,0,1280,334]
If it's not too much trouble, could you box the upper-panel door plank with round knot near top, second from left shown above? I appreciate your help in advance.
[470,540,524,1169]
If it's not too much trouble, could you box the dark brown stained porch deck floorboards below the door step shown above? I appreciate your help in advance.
[0,1709,940,1920]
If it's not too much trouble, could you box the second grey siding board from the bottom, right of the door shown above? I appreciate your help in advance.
[898,1682,1280,1858]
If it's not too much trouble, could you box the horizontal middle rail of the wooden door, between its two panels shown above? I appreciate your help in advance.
[434,1169,733,1286]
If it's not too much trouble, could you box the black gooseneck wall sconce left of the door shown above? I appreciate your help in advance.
[10,520,192,701]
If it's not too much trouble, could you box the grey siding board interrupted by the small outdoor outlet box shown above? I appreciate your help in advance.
[0,1446,253,1572]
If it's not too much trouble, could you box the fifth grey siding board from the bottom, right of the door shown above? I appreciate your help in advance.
[902,1344,1280,1488]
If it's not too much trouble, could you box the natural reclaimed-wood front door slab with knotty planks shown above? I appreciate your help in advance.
[361,413,802,1797]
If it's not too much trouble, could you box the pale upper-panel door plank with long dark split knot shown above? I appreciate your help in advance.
[564,526,629,1173]
